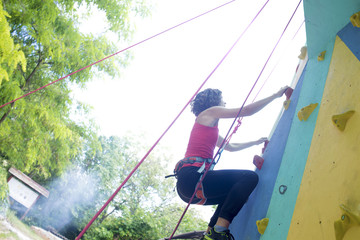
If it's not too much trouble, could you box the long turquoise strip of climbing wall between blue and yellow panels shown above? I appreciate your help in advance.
[261,43,333,240]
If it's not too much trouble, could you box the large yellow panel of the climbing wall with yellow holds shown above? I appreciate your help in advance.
[288,37,360,240]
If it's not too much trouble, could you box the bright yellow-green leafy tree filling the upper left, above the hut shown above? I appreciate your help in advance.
[0,0,148,182]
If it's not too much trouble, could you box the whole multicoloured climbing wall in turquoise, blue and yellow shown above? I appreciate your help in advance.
[231,0,360,240]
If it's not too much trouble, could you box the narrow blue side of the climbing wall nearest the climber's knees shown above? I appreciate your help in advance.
[230,62,304,240]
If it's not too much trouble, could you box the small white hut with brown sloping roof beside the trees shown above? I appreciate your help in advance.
[8,167,49,220]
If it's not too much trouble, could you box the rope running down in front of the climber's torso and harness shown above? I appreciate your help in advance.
[169,0,302,240]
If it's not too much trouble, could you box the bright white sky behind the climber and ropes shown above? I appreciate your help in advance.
[75,0,305,172]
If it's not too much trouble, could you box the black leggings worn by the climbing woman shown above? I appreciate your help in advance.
[176,167,259,227]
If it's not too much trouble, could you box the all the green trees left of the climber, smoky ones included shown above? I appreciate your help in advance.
[0,0,206,240]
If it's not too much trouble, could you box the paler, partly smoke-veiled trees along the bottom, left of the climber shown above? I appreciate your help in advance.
[27,137,206,240]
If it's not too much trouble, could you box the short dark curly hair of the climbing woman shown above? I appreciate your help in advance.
[190,88,222,116]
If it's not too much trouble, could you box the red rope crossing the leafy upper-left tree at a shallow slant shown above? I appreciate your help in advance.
[0,0,235,108]
